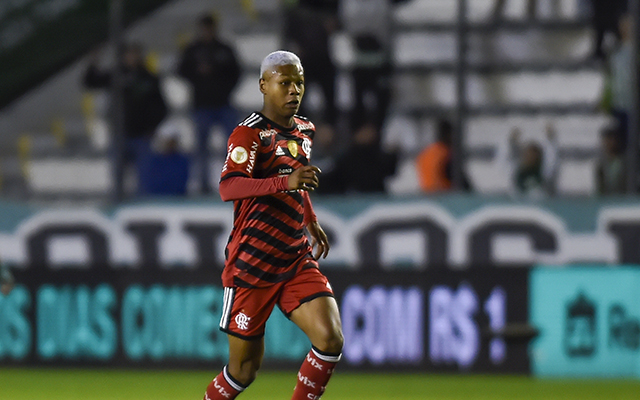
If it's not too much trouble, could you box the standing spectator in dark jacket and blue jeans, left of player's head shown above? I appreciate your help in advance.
[178,14,241,193]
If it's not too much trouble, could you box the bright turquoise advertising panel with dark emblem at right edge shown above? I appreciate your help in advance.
[530,267,640,377]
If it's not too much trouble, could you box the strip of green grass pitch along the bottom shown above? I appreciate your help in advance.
[0,368,640,400]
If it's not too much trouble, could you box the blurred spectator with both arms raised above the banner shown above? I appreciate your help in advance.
[497,124,558,199]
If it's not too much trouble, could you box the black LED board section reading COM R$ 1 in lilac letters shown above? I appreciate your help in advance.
[330,268,529,373]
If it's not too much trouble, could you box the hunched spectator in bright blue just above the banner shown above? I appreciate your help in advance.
[141,127,190,196]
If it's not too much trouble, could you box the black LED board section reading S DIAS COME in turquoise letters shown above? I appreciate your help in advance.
[0,283,310,365]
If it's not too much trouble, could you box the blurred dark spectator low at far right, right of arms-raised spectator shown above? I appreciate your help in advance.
[596,128,626,195]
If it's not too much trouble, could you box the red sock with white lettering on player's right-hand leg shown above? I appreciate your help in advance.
[291,347,341,400]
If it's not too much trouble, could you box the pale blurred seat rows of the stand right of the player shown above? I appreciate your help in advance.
[388,0,607,195]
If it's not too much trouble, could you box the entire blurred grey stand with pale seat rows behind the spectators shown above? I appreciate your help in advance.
[0,0,607,201]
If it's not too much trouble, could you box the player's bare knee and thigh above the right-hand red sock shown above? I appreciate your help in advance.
[289,296,343,352]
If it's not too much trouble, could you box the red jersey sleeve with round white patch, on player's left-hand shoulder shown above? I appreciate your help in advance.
[220,126,260,182]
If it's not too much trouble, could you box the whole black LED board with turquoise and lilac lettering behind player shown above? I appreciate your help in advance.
[0,268,529,373]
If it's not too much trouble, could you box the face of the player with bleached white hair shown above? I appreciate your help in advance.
[260,65,304,122]
